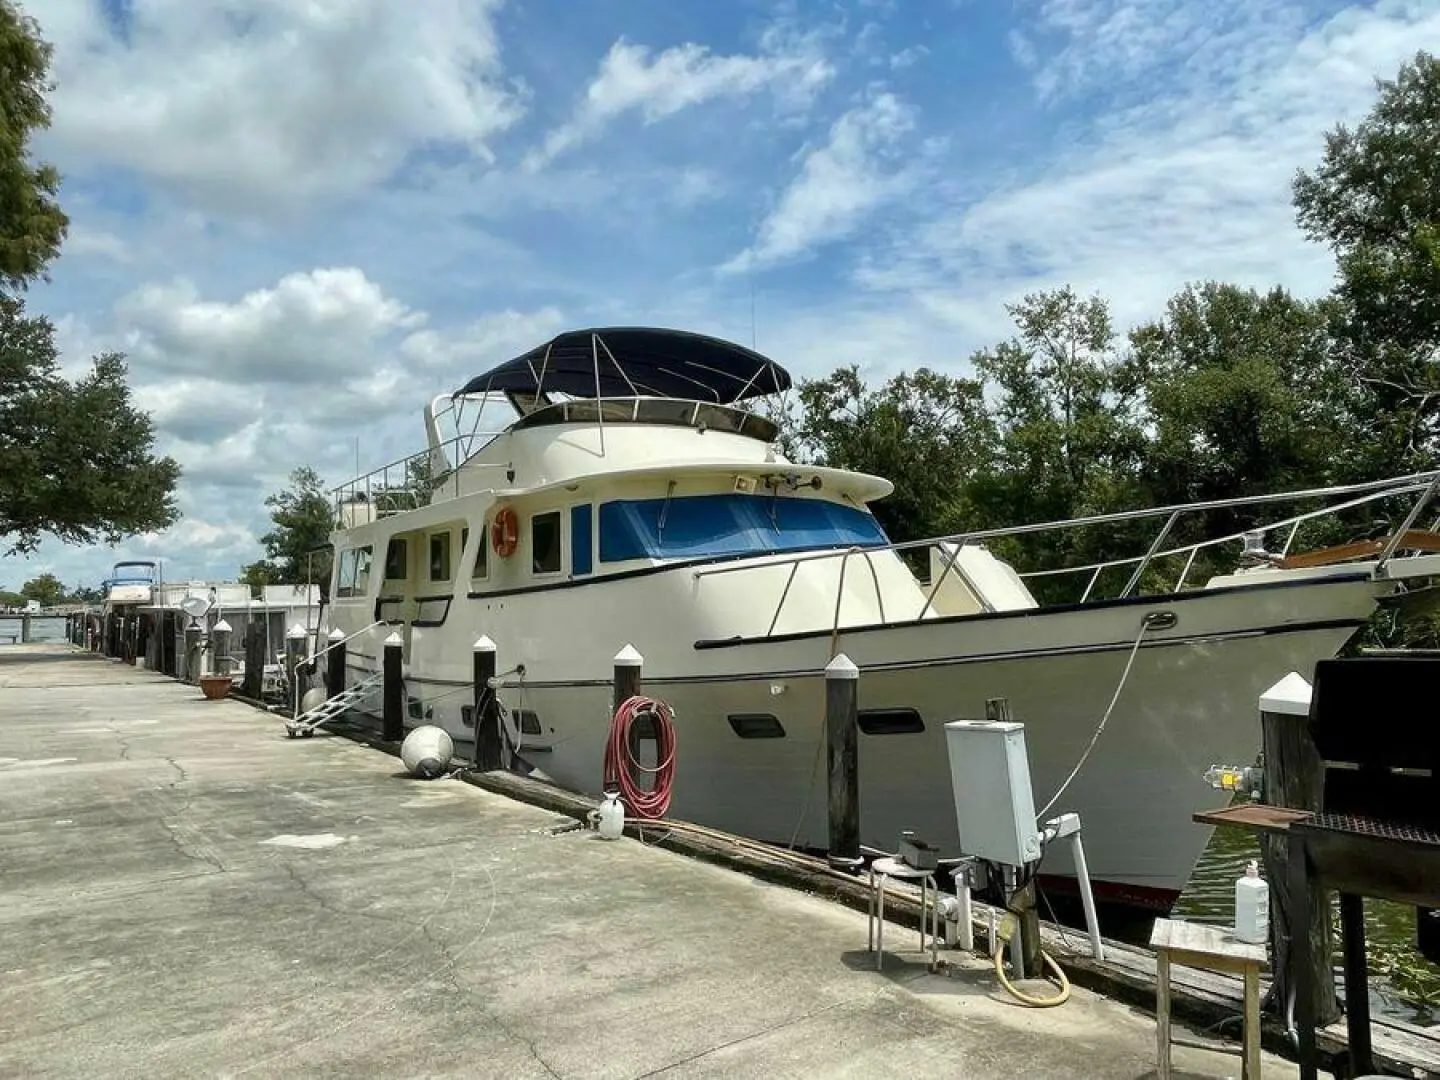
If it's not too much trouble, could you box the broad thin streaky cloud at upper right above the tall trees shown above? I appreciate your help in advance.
[857,1,1440,343]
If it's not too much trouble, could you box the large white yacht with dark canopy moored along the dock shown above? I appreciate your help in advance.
[327,328,1440,907]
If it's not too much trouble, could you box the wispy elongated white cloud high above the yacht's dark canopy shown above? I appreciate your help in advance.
[526,32,834,170]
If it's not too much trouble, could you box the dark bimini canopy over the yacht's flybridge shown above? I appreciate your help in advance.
[455,327,791,405]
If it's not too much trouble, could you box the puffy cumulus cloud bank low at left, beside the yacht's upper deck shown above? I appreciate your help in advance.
[16,266,563,593]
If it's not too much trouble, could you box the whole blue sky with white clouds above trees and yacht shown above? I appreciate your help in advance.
[0,0,1440,601]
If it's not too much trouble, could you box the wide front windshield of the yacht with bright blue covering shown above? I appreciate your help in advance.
[599,494,887,563]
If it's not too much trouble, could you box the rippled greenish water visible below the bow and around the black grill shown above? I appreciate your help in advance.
[1172,828,1440,1024]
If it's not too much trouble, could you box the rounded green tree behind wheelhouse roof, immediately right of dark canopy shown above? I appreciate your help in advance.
[779,367,991,541]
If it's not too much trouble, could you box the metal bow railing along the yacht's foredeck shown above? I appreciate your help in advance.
[694,471,1440,636]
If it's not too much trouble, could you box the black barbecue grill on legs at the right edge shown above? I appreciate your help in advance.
[1289,654,1440,1080]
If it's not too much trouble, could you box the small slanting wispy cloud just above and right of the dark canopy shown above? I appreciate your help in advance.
[721,94,916,272]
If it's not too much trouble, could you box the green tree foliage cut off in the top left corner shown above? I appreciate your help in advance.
[0,0,69,289]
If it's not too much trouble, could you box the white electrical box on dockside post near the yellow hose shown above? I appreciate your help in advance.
[945,720,1040,867]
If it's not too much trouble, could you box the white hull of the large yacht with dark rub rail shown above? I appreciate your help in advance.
[339,572,1382,907]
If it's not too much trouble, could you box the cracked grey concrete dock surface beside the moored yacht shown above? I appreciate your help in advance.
[0,645,1296,1080]
